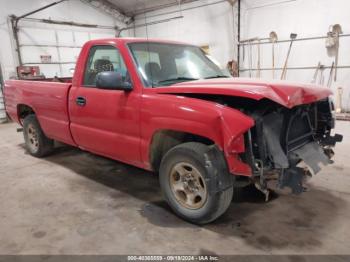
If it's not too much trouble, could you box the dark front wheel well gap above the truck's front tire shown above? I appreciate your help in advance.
[150,130,215,171]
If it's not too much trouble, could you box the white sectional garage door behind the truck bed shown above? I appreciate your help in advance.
[18,22,115,77]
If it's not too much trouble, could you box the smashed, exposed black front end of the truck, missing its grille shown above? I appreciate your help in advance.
[241,99,342,199]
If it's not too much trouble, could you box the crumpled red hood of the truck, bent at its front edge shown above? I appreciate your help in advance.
[152,78,332,108]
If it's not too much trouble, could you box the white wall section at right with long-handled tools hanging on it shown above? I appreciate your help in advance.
[241,0,350,110]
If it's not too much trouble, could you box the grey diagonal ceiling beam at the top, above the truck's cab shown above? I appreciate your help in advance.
[80,0,133,25]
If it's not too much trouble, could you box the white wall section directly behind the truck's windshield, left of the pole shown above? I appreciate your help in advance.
[134,0,236,66]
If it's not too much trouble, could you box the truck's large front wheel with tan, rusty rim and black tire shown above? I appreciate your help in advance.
[159,142,233,224]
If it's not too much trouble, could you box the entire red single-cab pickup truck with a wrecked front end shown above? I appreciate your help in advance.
[5,38,342,224]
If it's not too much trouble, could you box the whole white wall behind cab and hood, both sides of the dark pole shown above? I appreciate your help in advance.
[133,0,350,110]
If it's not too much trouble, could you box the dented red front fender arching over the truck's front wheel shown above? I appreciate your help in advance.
[141,94,254,175]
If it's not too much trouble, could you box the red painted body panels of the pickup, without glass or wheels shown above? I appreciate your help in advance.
[5,39,331,175]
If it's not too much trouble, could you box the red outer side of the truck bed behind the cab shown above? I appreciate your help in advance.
[5,79,74,145]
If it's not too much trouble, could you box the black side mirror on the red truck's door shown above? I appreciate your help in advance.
[96,71,132,91]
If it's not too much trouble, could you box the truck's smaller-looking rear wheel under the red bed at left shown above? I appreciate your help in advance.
[23,115,54,157]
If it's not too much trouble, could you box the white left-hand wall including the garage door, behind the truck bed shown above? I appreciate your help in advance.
[0,0,127,79]
